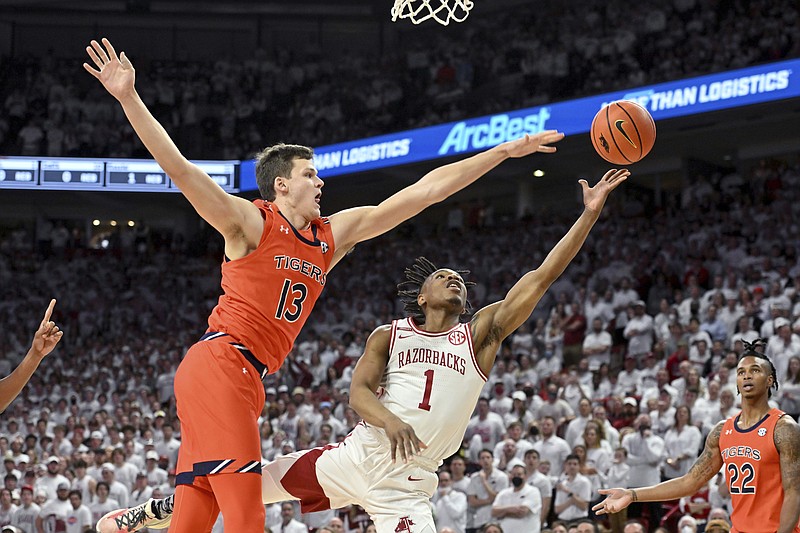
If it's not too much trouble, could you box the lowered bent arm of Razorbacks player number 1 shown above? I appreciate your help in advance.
[350,325,426,463]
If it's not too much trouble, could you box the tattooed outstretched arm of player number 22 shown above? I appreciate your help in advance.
[592,420,725,514]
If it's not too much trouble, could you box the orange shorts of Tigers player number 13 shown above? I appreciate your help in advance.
[175,336,265,485]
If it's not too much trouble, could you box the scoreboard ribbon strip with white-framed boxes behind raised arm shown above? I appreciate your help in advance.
[0,157,239,193]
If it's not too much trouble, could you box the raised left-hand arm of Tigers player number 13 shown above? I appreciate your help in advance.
[83,38,263,242]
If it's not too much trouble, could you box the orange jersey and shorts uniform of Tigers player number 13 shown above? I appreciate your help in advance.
[175,200,335,485]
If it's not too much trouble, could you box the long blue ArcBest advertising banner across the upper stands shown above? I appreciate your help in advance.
[241,59,800,190]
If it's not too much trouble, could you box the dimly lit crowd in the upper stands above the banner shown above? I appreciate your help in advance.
[0,0,800,159]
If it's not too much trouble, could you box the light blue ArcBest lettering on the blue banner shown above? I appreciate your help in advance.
[439,107,550,155]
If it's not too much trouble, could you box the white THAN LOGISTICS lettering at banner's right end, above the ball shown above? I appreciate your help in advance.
[600,69,792,111]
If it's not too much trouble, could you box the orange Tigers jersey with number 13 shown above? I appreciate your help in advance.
[208,200,335,373]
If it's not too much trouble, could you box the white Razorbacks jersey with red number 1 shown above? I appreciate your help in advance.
[379,318,486,464]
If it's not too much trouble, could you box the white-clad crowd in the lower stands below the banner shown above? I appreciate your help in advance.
[0,148,800,532]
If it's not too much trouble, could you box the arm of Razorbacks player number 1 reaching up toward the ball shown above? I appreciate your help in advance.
[472,169,630,371]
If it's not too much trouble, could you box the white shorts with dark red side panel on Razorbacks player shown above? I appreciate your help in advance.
[262,423,439,533]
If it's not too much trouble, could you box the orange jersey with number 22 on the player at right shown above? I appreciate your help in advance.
[719,409,800,533]
